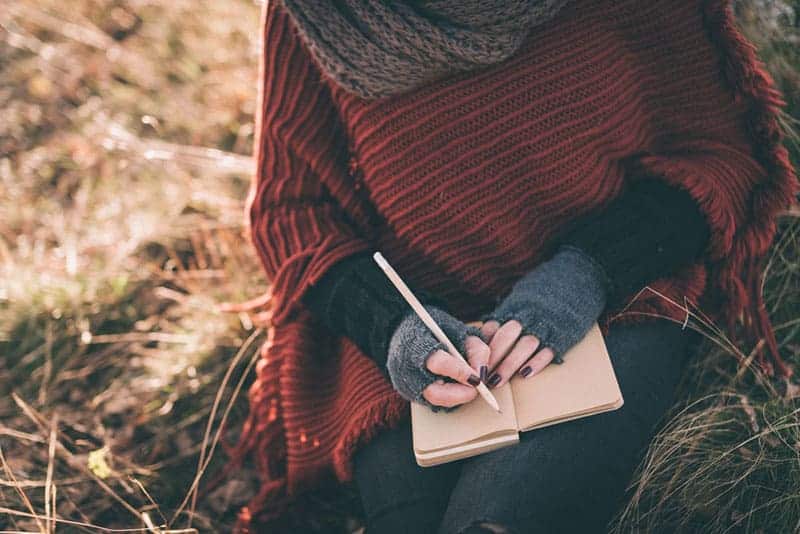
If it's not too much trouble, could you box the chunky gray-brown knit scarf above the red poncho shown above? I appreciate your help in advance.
[282,0,568,99]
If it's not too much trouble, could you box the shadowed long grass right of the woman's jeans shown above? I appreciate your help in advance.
[613,219,800,533]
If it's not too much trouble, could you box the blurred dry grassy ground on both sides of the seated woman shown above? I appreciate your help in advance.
[0,0,800,532]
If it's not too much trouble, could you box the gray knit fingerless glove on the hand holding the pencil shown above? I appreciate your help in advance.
[386,304,486,412]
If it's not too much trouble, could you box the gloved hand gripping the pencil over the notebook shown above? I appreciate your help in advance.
[386,305,490,411]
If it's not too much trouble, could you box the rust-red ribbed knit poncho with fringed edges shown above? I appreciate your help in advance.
[216,0,798,527]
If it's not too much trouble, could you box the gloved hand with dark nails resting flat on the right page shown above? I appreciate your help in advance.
[481,246,607,387]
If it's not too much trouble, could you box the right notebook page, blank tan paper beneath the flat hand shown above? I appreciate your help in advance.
[510,323,622,431]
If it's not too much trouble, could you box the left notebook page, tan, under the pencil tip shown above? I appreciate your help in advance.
[411,384,517,454]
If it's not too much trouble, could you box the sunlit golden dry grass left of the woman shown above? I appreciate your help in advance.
[0,1,266,532]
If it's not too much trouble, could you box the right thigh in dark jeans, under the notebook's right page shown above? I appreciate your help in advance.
[440,319,697,533]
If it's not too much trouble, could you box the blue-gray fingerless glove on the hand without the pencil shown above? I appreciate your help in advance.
[481,245,608,363]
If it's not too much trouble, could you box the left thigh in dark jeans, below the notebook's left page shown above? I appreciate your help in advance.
[353,418,460,534]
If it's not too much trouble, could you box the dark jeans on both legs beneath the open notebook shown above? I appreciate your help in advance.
[354,319,699,534]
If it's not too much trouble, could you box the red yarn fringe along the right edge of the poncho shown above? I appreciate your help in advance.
[601,0,800,378]
